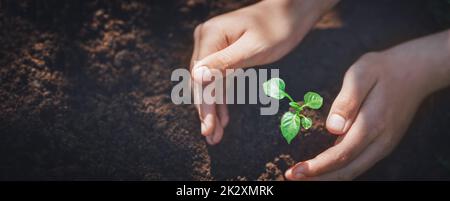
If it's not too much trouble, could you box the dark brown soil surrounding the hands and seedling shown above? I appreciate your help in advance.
[0,0,450,180]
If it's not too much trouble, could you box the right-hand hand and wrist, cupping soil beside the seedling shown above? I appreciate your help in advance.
[285,31,450,180]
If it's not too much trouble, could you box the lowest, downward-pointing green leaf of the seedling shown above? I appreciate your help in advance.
[280,112,300,144]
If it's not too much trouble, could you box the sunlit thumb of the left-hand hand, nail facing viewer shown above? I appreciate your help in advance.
[191,33,258,84]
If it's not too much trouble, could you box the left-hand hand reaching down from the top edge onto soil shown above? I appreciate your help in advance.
[191,0,337,144]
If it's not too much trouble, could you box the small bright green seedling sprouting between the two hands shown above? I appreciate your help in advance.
[263,78,323,144]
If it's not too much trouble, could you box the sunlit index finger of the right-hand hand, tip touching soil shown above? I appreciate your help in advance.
[286,86,383,180]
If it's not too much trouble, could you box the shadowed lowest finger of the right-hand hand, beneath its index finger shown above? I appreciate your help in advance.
[302,135,390,181]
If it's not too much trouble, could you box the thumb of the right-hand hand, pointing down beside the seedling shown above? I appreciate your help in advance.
[326,62,376,135]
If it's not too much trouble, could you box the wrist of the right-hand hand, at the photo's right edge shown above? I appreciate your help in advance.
[382,30,450,94]
